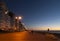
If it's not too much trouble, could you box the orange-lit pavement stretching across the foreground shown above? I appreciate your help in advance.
[0,31,60,41]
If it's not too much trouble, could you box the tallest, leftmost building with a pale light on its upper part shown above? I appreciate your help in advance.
[0,2,10,30]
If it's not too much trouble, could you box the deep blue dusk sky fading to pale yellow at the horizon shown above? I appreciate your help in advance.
[5,0,60,30]
